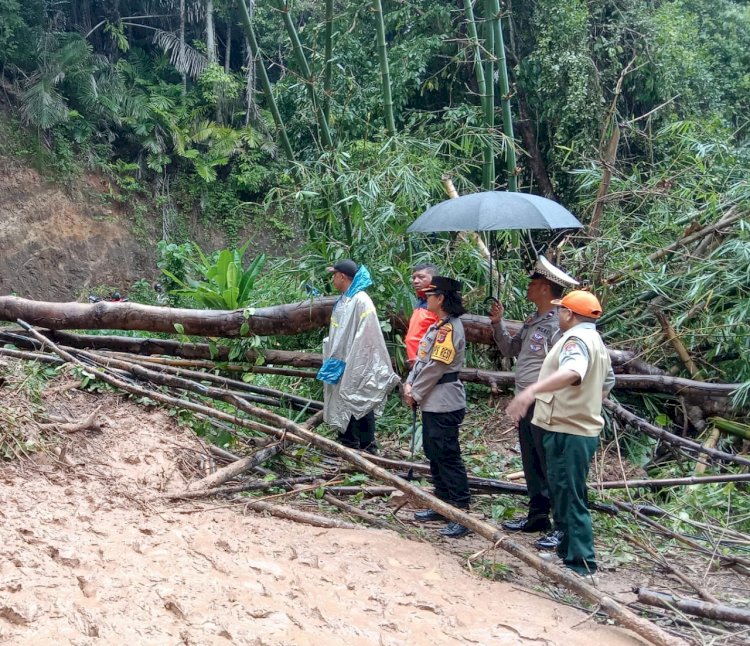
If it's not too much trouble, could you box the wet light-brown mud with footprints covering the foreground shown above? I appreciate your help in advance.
[0,391,642,646]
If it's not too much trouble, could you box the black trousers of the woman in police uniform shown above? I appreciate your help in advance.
[422,408,470,509]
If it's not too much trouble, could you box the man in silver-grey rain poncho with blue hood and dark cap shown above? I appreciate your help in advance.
[317,259,399,453]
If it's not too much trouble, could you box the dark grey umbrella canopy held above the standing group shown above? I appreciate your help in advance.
[407,191,583,233]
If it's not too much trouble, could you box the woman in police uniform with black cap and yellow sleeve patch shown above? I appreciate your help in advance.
[404,276,469,538]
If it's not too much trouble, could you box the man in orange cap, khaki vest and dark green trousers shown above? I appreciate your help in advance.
[506,290,614,575]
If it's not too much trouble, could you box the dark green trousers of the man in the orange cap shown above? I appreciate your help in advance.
[543,431,599,574]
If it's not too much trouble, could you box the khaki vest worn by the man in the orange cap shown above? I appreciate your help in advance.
[532,325,611,437]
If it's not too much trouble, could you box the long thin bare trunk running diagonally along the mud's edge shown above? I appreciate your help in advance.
[19,321,684,646]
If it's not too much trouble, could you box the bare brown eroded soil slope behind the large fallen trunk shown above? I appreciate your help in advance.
[0,157,154,301]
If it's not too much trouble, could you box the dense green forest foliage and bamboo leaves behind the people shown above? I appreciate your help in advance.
[0,0,750,401]
